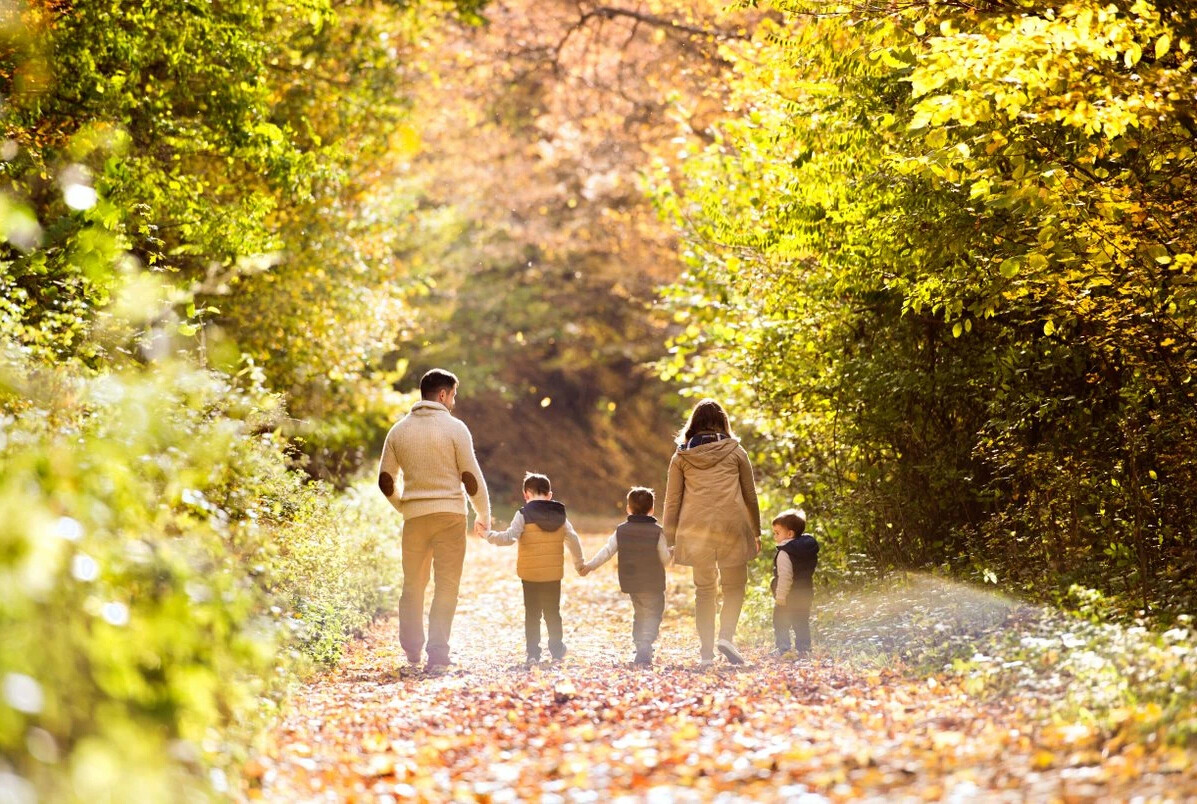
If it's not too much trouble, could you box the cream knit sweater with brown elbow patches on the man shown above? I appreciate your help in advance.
[378,400,491,524]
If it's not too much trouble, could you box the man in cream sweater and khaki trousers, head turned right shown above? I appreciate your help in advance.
[378,369,491,672]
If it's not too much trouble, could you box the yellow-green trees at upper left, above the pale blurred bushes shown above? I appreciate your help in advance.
[0,0,479,480]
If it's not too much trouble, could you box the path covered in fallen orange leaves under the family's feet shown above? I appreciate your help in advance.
[243,536,1197,800]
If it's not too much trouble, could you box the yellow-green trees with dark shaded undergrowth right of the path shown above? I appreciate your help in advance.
[657,0,1197,611]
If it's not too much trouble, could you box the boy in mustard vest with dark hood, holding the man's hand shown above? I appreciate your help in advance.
[486,471,583,665]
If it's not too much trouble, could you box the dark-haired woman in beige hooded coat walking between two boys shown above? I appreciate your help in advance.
[664,400,760,665]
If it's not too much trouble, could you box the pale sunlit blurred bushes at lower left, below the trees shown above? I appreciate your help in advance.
[0,353,399,800]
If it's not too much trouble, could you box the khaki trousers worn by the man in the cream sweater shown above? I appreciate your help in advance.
[399,513,466,664]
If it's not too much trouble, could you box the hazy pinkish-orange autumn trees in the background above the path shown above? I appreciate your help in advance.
[383,0,759,504]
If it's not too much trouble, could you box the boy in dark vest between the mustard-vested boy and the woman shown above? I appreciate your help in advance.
[582,486,673,665]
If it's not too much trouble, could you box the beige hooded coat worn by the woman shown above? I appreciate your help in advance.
[663,438,760,568]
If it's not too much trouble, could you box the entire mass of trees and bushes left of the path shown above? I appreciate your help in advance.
[0,0,480,800]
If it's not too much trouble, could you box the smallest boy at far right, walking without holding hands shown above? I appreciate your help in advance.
[771,508,819,656]
